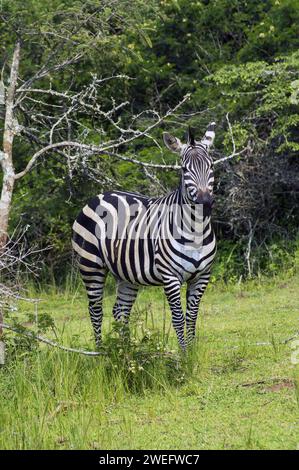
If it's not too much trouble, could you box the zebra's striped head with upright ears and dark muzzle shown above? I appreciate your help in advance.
[163,122,215,215]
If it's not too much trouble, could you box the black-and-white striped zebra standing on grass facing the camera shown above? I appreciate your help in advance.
[72,122,216,350]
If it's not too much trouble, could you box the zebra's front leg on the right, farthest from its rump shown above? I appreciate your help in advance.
[186,273,210,345]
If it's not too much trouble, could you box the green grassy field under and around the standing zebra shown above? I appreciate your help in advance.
[0,277,299,449]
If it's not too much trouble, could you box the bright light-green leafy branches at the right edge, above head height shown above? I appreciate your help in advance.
[207,52,299,153]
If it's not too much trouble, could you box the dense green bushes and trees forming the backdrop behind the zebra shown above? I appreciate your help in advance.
[0,0,299,279]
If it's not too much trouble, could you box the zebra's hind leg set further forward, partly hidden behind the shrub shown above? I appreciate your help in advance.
[113,280,138,336]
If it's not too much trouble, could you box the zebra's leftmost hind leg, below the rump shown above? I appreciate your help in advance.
[80,264,107,347]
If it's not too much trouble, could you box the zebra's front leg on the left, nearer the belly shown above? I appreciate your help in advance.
[164,278,186,351]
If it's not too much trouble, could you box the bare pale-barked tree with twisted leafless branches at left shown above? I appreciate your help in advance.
[0,35,195,248]
